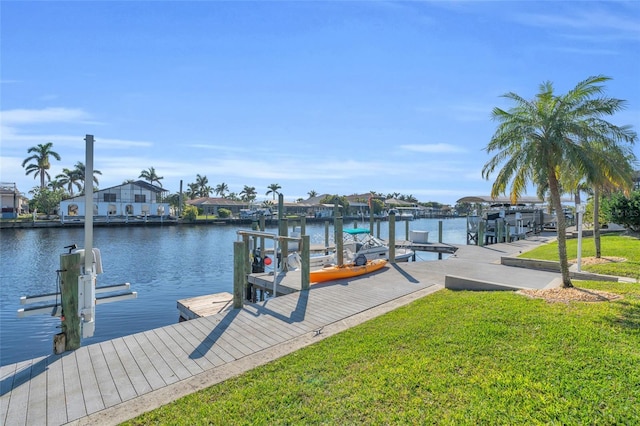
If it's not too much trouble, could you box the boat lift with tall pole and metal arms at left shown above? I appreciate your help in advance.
[18,135,138,354]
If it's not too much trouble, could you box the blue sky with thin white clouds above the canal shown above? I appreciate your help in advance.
[0,0,640,204]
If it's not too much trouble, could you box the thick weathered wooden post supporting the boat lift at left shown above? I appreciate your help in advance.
[60,253,82,351]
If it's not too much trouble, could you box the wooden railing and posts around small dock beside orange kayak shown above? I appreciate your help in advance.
[238,231,311,308]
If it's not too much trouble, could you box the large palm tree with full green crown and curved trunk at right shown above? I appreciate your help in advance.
[482,76,636,287]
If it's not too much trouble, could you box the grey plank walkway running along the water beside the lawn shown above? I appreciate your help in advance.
[0,262,444,426]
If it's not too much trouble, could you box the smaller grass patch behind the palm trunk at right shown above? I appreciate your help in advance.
[519,235,640,279]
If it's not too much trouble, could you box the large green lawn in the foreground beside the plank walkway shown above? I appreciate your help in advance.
[127,282,640,425]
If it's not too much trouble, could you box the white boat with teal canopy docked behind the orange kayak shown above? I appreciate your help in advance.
[342,228,415,262]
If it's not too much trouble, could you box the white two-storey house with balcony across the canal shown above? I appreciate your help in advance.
[59,180,169,222]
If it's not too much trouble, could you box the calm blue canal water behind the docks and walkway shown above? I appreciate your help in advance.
[0,218,466,365]
